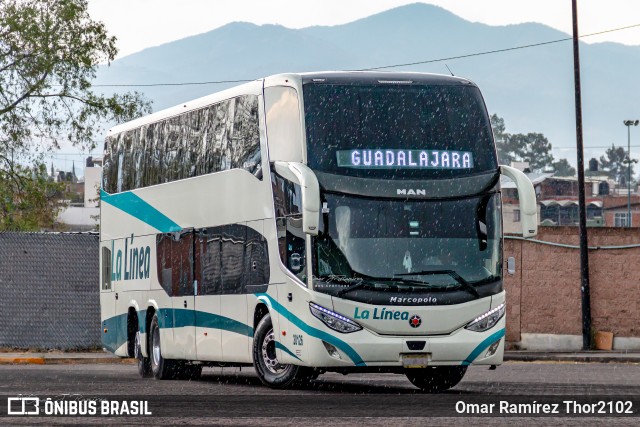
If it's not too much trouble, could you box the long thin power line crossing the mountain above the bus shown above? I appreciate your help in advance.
[92,24,640,87]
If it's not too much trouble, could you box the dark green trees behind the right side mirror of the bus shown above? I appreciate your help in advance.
[491,114,554,170]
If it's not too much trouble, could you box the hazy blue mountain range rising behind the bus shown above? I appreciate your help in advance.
[95,3,640,163]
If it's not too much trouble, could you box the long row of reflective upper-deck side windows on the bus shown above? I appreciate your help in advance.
[102,95,261,193]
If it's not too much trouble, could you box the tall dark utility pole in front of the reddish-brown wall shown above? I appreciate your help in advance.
[571,0,591,350]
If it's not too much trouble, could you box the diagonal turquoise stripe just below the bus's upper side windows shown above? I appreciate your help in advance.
[100,190,182,233]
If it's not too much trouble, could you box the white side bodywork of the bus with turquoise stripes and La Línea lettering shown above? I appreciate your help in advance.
[102,169,273,362]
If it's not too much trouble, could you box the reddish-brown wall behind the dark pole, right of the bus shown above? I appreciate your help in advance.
[504,227,640,349]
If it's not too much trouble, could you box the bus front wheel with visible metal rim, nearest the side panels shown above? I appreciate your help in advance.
[253,314,310,388]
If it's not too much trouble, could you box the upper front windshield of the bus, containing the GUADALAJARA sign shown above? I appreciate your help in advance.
[303,83,497,179]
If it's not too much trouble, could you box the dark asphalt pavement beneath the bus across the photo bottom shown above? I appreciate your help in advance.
[0,361,640,427]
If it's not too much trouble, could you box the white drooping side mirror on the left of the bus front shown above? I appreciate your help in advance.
[273,162,320,236]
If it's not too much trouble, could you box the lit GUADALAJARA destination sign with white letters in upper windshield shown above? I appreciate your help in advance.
[336,149,473,169]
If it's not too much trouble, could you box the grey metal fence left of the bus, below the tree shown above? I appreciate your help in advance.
[0,232,100,350]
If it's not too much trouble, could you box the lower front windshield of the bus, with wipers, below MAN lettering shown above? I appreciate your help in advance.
[313,193,502,291]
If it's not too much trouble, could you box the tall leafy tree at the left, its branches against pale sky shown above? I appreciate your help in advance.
[0,0,150,231]
